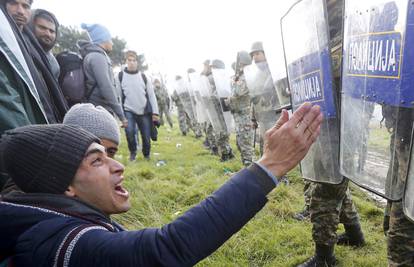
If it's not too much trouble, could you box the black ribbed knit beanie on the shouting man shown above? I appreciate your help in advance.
[0,124,100,194]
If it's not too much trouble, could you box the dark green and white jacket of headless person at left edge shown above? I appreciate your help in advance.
[0,5,47,189]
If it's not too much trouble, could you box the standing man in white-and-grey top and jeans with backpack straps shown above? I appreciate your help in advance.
[118,51,159,161]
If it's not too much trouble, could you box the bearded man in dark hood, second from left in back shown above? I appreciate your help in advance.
[29,9,60,80]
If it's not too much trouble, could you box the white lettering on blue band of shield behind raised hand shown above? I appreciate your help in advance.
[292,76,322,103]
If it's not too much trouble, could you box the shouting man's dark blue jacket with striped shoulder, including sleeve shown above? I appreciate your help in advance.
[0,164,275,267]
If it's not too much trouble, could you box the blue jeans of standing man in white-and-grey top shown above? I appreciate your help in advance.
[125,111,152,157]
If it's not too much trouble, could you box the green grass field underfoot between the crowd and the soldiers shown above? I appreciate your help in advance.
[111,124,387,267]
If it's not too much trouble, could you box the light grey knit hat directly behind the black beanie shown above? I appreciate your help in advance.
[63,103,121,145]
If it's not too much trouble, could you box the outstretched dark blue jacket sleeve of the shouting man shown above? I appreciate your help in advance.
[70,165,274,266]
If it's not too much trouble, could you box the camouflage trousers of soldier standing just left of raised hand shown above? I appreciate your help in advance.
[233,112,254,166]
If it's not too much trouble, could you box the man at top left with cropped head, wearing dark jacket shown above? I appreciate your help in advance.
[0,0,68,123]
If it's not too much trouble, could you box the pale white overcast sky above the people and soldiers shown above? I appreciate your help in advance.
[33,0,295,80]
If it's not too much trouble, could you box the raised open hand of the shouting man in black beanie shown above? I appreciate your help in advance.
[258,103,323,177]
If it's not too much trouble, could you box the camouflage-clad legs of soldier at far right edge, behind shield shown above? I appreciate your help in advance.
[382,105,414,267]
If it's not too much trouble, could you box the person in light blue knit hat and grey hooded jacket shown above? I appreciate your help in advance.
[78,23,128,128]
